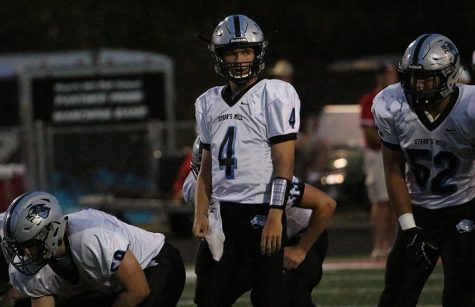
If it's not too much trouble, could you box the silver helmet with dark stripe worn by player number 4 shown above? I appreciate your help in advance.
[208,15,267,84]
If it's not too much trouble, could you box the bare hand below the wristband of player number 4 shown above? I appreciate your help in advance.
[261,209,282,256]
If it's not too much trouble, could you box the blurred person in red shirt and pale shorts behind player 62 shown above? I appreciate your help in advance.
[360,64,398,259]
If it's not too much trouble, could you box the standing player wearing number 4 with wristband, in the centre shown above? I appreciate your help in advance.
[193,15,300,306]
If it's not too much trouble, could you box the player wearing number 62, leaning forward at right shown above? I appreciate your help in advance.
[373,34,475,307]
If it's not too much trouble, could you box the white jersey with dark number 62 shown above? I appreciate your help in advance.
[372,83,475,209]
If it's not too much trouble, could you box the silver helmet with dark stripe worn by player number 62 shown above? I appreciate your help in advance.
[398,34,460,109]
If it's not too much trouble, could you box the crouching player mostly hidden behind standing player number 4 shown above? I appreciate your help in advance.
[183,137,336,307]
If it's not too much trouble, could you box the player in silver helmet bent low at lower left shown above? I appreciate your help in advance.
[2,192,185,307]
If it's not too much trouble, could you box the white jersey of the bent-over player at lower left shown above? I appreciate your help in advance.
[10,209,165,297]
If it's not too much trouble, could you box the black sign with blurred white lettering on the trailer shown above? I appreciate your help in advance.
[32,73,166,126]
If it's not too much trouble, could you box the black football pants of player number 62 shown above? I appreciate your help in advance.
[378,201,475,307]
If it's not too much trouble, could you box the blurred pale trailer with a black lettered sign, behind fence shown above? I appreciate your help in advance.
[0,50,183,214]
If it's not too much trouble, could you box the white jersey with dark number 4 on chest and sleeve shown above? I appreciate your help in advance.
[195,80,300,203]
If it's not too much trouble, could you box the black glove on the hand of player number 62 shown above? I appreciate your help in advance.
[404,227,439,271]
